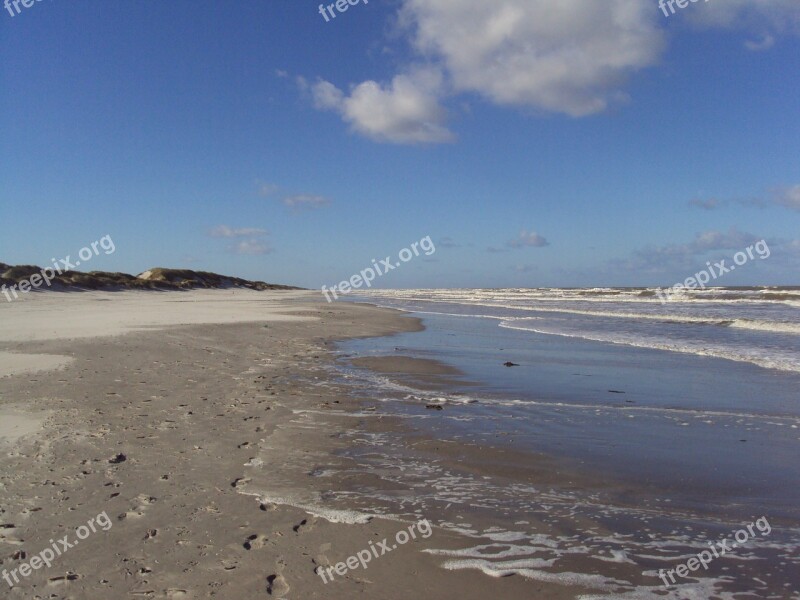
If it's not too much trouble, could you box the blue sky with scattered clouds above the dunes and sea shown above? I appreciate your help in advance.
[0,0,800,288]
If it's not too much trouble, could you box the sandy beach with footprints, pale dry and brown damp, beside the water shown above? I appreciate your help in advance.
[0,290,573,600]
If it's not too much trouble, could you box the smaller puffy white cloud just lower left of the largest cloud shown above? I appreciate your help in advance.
[311,69,454,144]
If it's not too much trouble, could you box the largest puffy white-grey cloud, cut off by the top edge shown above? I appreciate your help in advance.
[401,0,664,116]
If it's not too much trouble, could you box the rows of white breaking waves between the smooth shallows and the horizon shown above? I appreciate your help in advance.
[359,287,800,372]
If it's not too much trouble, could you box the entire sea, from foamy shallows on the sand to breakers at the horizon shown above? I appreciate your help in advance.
[324,288,800,598]
